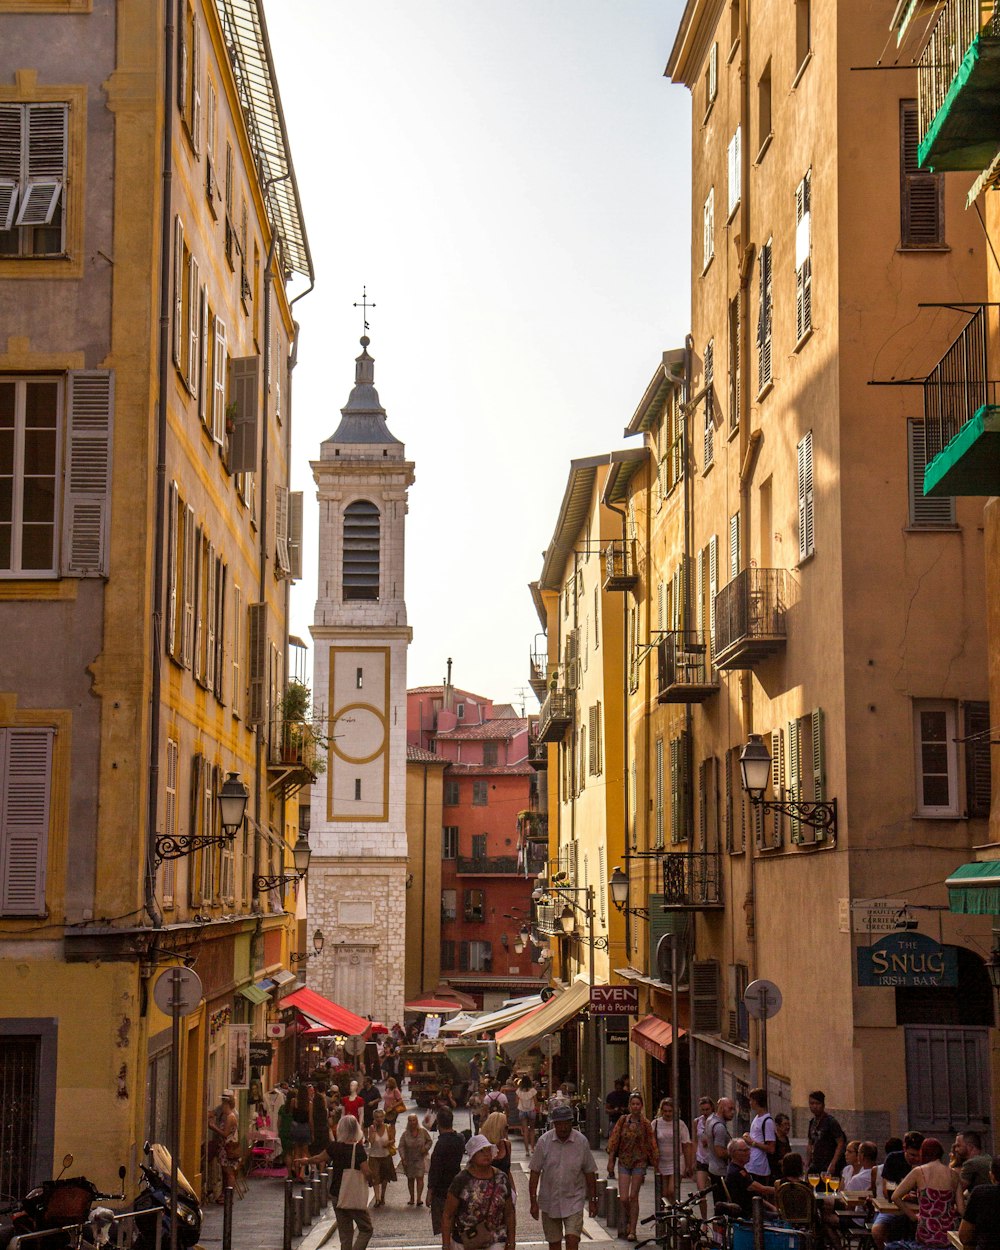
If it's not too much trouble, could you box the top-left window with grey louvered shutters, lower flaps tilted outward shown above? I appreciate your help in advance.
[0,104,68,256]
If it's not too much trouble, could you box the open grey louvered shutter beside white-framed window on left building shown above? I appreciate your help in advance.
[63,369,115,578]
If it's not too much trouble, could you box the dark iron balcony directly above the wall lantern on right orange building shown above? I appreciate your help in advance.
[713,569,789,669]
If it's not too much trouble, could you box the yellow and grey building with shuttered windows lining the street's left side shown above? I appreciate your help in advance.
[0,0,311,1194]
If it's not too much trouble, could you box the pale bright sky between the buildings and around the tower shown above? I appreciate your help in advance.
[265,0,690,713]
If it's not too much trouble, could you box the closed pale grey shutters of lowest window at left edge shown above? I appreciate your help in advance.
[0,729,54,916]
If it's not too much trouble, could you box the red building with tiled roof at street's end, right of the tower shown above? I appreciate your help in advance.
[406,684,548,1009]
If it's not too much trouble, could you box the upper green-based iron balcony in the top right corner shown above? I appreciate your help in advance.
[918,0,1000,173]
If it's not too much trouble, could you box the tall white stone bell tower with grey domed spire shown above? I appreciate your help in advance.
[309,336,414,1025]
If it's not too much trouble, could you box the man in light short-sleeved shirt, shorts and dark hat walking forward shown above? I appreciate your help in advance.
[529,1105,598,1250]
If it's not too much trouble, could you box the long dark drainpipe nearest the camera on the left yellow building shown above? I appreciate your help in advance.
[143,4,174,929]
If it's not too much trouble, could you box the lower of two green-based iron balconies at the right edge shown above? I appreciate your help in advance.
[924,308,1000,496]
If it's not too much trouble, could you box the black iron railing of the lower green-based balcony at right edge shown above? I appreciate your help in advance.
[924,308,1000,461]
